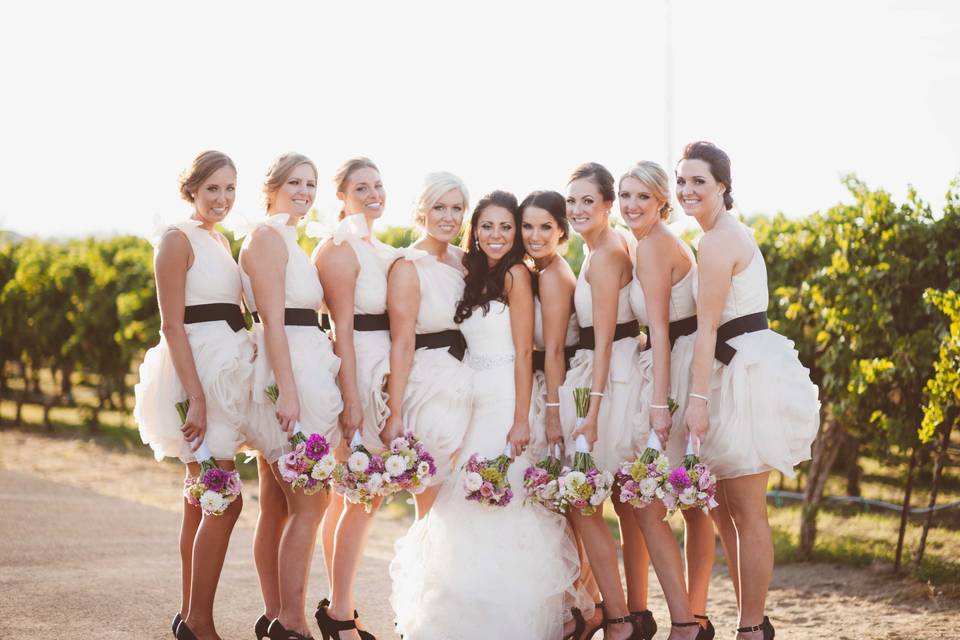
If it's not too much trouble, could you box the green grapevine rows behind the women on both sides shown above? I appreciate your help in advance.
[0,177,960,564]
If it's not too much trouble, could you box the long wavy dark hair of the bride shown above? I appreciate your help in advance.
[453,191,524,324]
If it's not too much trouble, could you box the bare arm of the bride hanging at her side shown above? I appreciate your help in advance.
[506,264,533,457]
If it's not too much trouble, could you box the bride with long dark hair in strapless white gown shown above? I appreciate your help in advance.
[390,191,578,640]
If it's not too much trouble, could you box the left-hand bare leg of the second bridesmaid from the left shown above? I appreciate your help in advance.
[253,456,287,620]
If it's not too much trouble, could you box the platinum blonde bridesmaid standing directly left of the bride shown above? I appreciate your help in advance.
[382,173,471,519]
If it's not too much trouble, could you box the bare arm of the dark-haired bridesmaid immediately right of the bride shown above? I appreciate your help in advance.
[540,265,576,459]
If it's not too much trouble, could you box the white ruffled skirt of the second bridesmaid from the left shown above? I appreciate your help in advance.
[246,324,343,464]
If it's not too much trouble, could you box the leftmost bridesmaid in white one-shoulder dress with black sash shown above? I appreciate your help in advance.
[133,151,253,639]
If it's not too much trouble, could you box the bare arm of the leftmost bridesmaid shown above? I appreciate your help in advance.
[153,229,207,451]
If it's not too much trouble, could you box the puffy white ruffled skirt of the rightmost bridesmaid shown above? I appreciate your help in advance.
[700,330,820,479]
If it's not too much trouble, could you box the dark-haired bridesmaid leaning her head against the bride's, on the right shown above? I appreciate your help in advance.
[520,191,603,639]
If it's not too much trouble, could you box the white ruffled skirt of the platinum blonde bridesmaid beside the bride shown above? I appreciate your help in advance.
[401,349,473,484]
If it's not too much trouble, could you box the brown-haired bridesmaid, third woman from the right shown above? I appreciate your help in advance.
[560,162,656,639]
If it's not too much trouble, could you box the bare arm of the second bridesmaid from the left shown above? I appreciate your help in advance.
[240,227,300,433]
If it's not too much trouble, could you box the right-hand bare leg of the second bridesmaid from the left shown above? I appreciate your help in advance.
[271,465,327,635]
